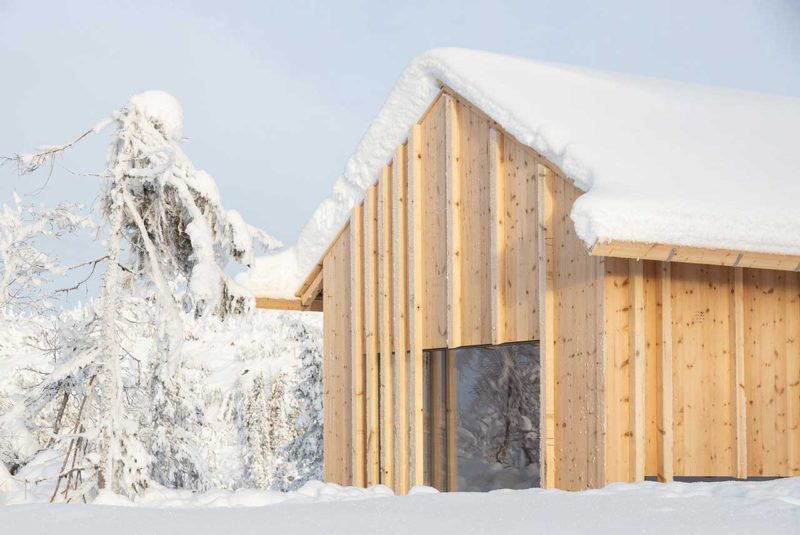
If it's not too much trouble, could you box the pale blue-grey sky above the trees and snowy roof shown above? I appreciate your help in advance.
[0,0,800,255]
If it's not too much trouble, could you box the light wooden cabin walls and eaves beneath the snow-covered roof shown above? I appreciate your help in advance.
[259,56,800,493]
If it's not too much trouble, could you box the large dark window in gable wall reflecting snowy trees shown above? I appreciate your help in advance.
[425,342,539,491]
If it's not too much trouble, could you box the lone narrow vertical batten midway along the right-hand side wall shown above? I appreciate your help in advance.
[656,262,674,483]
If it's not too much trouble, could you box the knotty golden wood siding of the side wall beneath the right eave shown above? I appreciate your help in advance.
[605,258,800,481]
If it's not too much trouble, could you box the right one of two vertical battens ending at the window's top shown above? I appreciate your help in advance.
[489,128,507,345]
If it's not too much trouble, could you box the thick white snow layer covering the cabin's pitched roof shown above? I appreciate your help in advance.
[240,49,800,297]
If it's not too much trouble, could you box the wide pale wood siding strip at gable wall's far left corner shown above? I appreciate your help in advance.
[322,228,353,485]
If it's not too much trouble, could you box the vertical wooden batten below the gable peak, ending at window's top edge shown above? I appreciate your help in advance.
[444,95,463,347]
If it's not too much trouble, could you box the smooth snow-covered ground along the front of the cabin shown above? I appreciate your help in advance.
[0,478,800,535]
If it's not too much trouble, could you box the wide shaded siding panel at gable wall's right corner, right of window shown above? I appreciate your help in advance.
[548,170,604,490]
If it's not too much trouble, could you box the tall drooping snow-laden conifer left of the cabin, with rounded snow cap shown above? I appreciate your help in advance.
[4,91,280,494]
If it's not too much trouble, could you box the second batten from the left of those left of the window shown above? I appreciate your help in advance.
[364,186,380,485]
